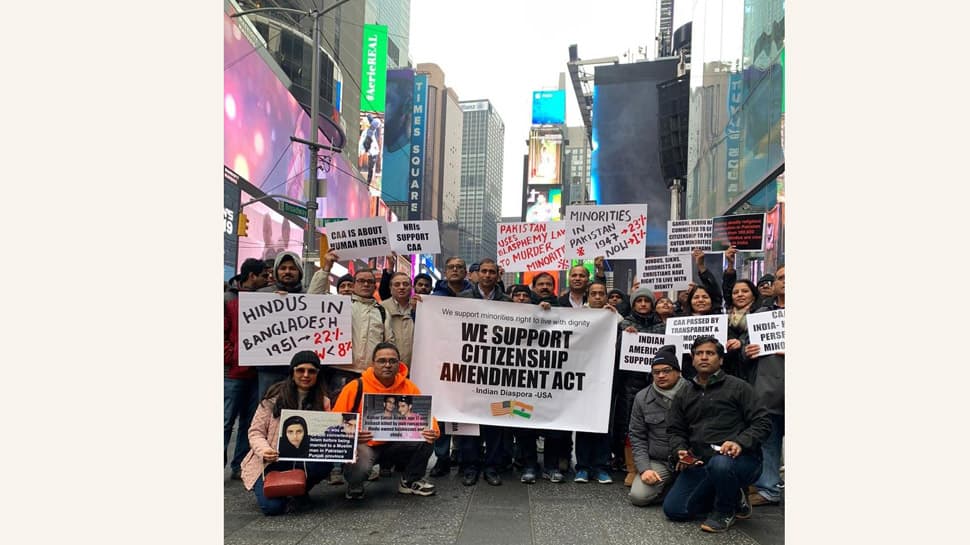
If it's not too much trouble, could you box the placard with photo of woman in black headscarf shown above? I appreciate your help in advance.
[276,409,358,462]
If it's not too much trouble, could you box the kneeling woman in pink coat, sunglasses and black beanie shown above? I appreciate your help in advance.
[242,350,333,515]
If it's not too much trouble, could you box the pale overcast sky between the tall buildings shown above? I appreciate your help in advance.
[410,0,656,216]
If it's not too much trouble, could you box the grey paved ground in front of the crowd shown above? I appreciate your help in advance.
[224,438,785,545]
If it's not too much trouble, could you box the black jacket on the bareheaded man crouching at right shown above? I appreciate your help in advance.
[667,370,771,462]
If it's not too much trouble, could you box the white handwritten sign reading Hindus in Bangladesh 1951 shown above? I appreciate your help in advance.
[239,291,354,366]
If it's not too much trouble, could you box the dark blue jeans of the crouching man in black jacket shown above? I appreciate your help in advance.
[664,453,761,521]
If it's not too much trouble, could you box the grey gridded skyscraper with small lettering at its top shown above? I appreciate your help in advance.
[458,99,505,263]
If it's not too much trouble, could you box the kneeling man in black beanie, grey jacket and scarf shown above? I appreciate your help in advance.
[629,345,687,507]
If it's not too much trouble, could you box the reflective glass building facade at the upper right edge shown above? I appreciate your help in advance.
[686,0,785,278]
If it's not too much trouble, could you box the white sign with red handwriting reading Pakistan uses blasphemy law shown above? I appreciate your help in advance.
[495,221,569,272]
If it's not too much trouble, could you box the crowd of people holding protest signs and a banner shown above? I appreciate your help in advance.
[224,247,785,532]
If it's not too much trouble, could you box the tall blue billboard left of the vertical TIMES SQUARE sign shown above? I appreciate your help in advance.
[381,68,414,203]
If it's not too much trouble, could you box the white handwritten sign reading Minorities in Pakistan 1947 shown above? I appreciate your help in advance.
[564,204,647,259]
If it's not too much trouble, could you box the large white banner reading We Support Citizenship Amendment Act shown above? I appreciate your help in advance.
[411,295,616,433]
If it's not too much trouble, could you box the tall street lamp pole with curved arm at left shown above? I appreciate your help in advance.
[230,0,350,287]
